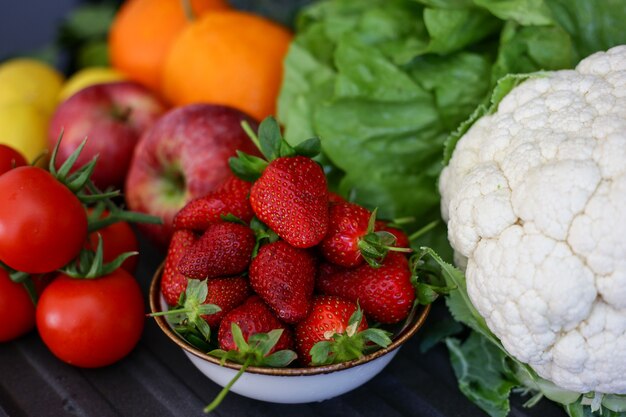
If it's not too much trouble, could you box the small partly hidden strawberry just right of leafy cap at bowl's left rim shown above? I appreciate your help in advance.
[201,276,251,328]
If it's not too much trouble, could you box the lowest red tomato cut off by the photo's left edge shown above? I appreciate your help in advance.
[0,268,35,342]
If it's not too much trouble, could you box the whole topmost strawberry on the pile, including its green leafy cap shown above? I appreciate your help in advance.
[229,117,329,248]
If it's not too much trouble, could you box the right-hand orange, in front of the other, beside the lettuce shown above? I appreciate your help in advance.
[162,10,293,120]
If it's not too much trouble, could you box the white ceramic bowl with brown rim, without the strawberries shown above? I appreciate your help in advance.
[149,268,430,404]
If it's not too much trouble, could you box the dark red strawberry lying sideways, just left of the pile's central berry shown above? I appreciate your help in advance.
[178,222,256,279]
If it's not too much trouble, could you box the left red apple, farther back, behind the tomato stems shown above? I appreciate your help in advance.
[48,81,167,189]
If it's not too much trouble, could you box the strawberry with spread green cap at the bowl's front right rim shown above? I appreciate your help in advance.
[295,295,391,365]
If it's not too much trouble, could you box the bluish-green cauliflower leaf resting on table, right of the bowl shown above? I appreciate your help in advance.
[446,333,517,417]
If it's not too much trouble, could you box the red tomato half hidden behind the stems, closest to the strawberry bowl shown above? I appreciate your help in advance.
[85,215,139,274]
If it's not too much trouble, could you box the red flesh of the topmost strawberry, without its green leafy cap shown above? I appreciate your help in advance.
[250,156,328,248]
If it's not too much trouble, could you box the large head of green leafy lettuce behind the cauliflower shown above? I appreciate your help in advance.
[278,0,626,257]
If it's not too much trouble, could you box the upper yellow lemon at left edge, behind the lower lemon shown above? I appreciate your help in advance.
[0,58,63,114]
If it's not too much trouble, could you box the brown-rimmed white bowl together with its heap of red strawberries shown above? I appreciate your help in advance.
[149,118,436,412]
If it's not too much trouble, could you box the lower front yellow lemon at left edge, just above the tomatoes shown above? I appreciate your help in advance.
[0,103,49,162]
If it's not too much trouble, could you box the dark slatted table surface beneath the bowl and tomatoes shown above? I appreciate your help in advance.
[0,236,565,417]
